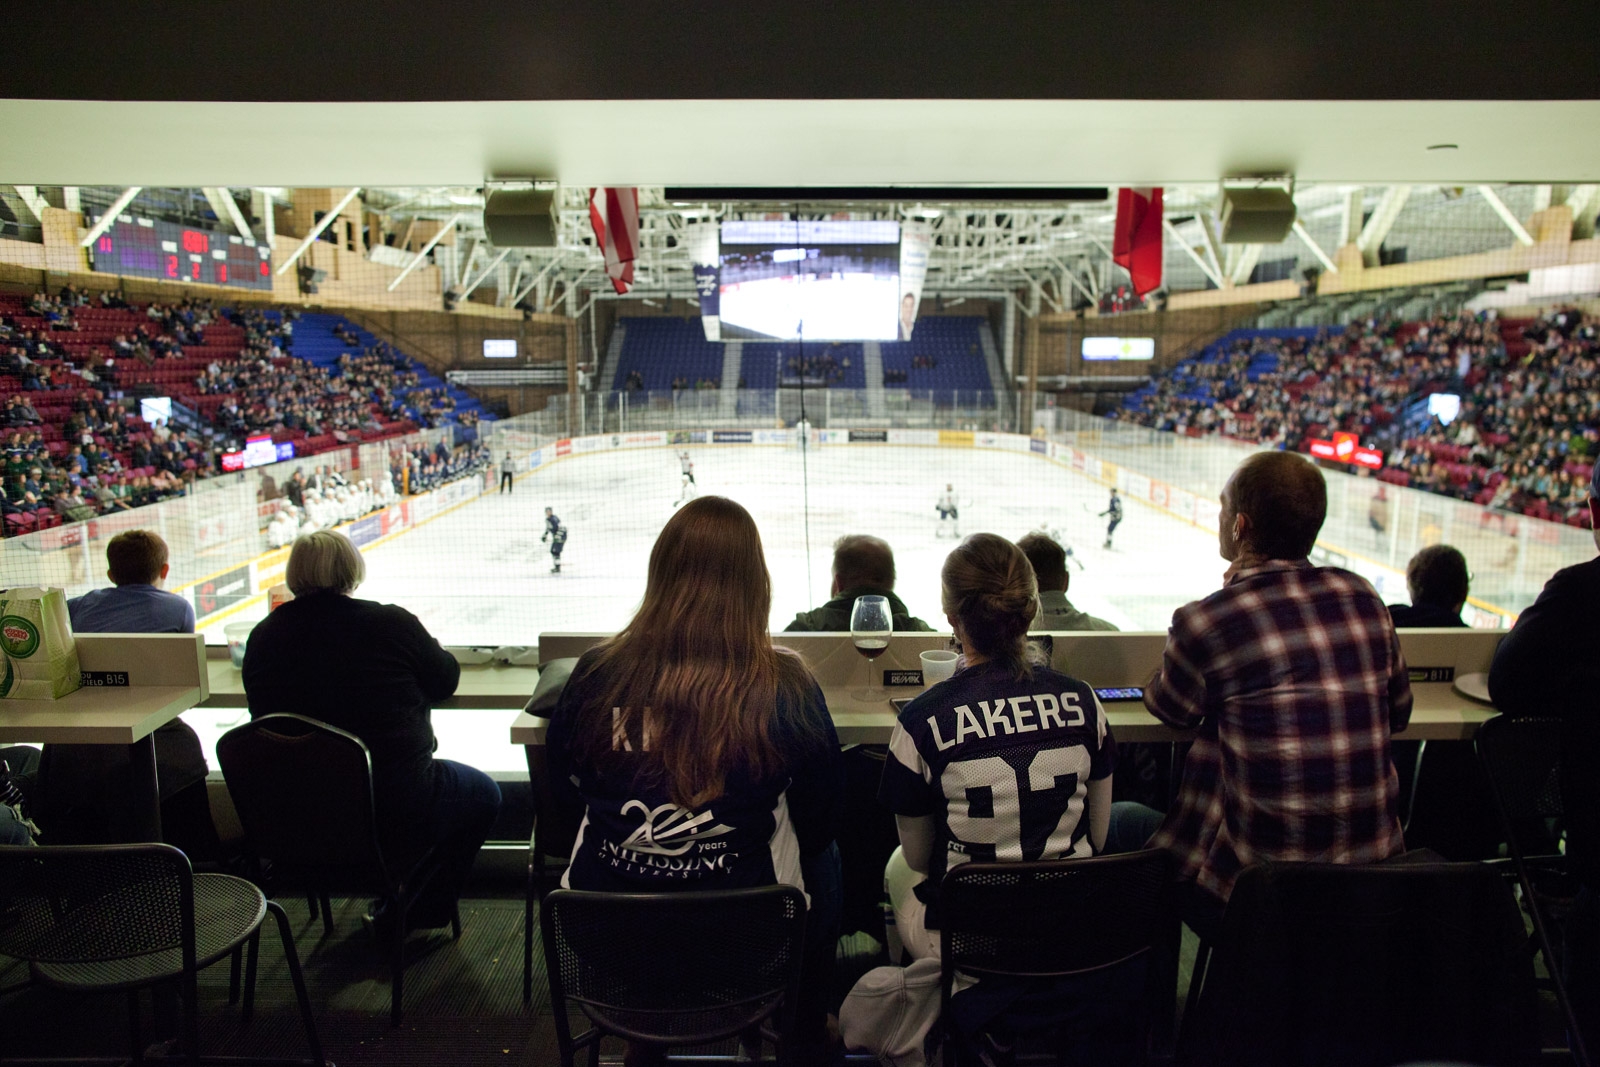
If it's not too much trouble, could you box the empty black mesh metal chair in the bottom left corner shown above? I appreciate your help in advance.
[0,845,325,1067]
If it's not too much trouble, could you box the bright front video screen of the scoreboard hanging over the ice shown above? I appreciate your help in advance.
[718,221,901,341]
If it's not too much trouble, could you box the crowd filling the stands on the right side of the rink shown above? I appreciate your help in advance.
[1114,310,1600,523]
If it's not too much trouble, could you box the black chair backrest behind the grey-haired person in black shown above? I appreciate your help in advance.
[216,715,382,869]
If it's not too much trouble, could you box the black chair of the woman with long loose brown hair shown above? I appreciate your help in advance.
[539,886,805,1067]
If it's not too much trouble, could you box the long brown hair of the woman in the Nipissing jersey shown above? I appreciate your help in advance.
[574,496,816,809]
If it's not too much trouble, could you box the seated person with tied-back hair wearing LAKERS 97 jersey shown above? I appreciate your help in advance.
[878,534,1115,958]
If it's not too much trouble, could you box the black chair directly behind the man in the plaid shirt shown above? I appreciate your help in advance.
[1184,859,1539,1067]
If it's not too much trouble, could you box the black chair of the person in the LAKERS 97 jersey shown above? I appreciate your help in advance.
[939,849,1173,1064]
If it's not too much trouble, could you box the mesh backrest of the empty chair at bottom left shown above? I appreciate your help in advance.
[0,845,194,966]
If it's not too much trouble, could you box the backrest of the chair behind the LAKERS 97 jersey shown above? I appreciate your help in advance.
[939,849,1173,977]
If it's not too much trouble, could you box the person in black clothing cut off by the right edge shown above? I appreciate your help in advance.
[1490,466,1600,1048]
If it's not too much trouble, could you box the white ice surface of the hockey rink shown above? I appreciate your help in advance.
[208,445,1226,646]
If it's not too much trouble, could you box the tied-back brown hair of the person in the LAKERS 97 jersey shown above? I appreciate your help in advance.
[939,534,1038,678]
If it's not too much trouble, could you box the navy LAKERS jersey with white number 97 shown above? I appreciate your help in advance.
[878,661,1117,921]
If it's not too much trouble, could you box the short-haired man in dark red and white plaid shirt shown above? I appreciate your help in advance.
[1144,453,1411,936]
